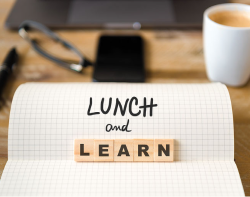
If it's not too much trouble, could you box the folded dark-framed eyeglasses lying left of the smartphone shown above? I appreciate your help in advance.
[18,20,92,73]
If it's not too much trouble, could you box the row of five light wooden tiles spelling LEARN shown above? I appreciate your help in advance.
[74,139,174,161]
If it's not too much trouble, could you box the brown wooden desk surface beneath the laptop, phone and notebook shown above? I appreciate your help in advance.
[0,0,250,196]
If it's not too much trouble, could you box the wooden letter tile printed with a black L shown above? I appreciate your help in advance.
[74,139,94,161]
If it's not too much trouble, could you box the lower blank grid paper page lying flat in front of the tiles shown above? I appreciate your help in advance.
[0,160,245,197]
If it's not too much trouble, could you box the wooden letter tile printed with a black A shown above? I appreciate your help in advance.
[114,139,134,161]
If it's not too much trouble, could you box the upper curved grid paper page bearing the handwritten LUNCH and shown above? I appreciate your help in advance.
[8,83,234,161]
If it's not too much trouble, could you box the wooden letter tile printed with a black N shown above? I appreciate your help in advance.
[154,139,174,161]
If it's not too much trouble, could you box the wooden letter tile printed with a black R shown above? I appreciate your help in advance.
[134,139,154,161]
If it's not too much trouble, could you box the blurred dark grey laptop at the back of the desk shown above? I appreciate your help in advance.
[5,0,227,29]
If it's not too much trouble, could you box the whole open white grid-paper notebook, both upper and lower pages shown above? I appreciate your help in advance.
[0,83,244,196]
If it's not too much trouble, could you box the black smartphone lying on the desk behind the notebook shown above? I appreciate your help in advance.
[93,35,145,82]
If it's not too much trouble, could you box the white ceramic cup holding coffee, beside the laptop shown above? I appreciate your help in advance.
[203,3,250,86]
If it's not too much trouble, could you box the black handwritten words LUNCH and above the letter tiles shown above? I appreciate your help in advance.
[87,97,158,132]
